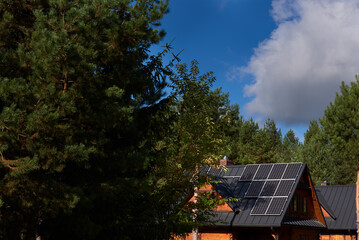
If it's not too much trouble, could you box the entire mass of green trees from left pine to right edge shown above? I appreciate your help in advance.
[0,0,359,240]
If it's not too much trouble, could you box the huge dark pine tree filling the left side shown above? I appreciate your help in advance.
[0,0,168,239]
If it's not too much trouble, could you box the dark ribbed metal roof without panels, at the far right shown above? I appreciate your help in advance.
[315,185,357,230]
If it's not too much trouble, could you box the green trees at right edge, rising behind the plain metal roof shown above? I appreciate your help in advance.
[301,77,359,184]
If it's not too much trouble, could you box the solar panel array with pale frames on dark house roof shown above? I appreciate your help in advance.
[240,163,302,215]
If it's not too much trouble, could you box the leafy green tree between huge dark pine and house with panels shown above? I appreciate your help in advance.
[157,61,235,235]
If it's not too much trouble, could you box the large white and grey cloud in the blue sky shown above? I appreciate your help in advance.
[235,0,359,124]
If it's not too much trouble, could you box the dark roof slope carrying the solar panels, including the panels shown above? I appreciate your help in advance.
[202,163,316,227]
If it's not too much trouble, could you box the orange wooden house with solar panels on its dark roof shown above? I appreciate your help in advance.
[179,163,327,240]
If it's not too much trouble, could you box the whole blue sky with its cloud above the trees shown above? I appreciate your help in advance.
[154,0,359,141]
